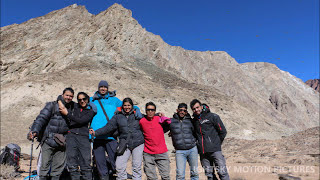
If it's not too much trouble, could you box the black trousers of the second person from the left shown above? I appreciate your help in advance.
[67,133,92,180]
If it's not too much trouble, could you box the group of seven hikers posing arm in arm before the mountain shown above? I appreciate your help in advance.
[28,80,229,180]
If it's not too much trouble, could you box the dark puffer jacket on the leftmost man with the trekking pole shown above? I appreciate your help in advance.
[31,95,74,148]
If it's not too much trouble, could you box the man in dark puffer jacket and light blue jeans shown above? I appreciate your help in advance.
[170,103,199,180]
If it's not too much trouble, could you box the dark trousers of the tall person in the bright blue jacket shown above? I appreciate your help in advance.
[93,139,118,177]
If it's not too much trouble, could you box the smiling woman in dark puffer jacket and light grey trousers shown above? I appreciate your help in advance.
[90,98,144,180]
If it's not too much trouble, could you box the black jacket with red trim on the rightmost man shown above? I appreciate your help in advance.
[193,109,227,154]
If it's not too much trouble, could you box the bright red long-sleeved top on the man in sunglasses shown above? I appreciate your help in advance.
[139,116,170,154]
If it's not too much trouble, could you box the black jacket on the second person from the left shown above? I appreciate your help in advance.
[67,103,97,137]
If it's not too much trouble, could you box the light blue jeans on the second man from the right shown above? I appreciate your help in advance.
[176,146,199,180]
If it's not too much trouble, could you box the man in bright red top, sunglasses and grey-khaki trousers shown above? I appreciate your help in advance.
[140,102,171,180]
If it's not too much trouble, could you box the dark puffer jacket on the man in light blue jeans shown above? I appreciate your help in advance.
[170,113,197,150]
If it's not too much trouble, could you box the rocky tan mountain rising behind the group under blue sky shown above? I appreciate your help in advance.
[1,4,319,145]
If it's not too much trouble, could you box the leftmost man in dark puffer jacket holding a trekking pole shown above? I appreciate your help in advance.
[29,88,74,180]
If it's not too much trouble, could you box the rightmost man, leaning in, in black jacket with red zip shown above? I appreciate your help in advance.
[190,99,230,180]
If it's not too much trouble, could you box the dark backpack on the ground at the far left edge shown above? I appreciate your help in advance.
[0,143,21,171]
